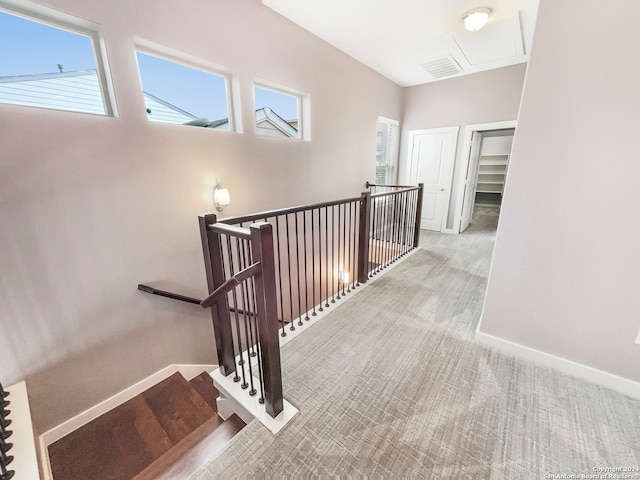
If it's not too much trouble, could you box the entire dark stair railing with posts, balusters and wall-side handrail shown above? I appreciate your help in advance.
[143,182,423,417]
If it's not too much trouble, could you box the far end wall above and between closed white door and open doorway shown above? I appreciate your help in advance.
[399,63,526,233]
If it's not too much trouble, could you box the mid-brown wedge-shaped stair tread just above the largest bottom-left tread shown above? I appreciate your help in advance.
[142,372,217,445]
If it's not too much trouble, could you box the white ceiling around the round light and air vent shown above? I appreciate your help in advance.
[262,0,538,86]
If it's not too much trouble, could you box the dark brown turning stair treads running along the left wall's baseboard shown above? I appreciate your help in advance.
[49,373,223,480]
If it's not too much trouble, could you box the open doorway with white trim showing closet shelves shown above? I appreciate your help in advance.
[459,122,515,232]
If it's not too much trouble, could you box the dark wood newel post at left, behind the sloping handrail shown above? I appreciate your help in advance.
[198,213,236,376]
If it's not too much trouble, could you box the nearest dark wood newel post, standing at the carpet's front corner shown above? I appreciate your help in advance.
[250,222,284,417]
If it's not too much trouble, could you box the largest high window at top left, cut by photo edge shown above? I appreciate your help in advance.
[0,6,113,115]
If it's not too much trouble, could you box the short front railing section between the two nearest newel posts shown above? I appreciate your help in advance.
[199,214,283,417]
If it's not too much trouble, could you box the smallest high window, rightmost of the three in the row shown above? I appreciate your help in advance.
[253,81,308,139]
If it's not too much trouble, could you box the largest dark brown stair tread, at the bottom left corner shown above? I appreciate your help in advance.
[49,395,173,480]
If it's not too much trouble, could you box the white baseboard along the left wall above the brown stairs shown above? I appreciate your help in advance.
[38,364,218,480]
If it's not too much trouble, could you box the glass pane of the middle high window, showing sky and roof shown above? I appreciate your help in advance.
[137,51,234,130]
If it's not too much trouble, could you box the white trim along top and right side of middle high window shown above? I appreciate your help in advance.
[135,37,242,133]
